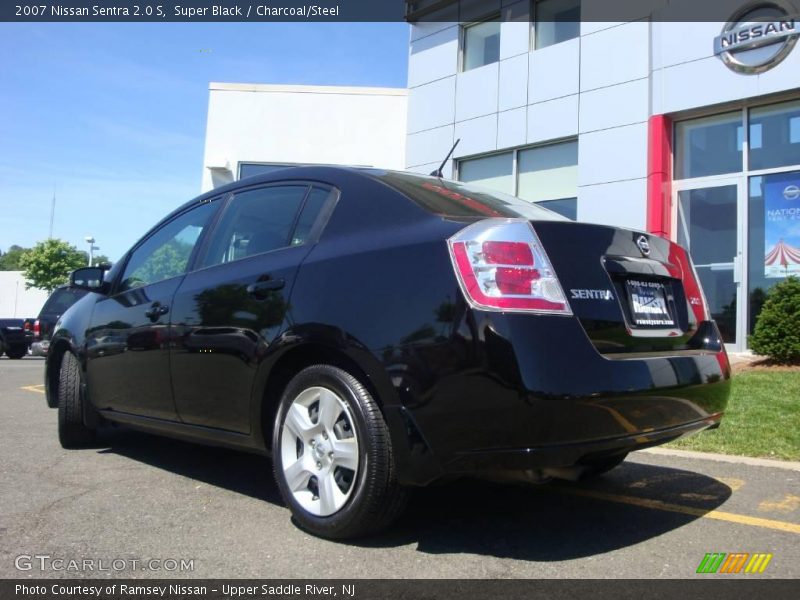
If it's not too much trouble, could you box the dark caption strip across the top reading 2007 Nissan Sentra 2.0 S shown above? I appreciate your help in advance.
[0,0,798,22]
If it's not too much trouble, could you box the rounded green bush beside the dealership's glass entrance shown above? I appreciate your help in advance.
[750,277,800,363]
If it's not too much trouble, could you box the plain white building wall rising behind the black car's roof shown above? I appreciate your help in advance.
[202,83,408,191]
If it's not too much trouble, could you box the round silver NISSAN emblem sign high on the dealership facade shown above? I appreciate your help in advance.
[714,0,800,74]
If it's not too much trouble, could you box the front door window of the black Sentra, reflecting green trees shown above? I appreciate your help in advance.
[121,202,217,291]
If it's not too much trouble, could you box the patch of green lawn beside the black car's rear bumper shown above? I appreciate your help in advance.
[670,370,800,460]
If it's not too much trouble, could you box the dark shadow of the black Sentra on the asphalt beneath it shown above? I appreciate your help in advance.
[95,429,731,562]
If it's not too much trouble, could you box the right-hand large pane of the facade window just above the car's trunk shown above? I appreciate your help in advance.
[517,142,578,202]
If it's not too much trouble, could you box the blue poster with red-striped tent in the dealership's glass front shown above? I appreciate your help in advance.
[764,172,800,278]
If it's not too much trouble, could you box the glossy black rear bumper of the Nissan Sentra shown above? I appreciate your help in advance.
[390,312,730,484]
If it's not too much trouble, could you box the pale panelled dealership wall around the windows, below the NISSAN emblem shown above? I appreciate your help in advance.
[406,0,800,229]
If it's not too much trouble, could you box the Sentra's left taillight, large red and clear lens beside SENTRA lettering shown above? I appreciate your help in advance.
[447,219,572,315]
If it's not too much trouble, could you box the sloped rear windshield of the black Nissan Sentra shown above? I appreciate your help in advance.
[371,171,569,221]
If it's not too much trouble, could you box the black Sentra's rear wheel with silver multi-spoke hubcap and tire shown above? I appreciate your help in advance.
[272,365,408,540]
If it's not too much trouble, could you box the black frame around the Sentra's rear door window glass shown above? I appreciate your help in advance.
[195,179,341,272]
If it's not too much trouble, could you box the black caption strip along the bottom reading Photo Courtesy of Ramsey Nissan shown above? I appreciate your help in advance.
[0,580,800,600]
